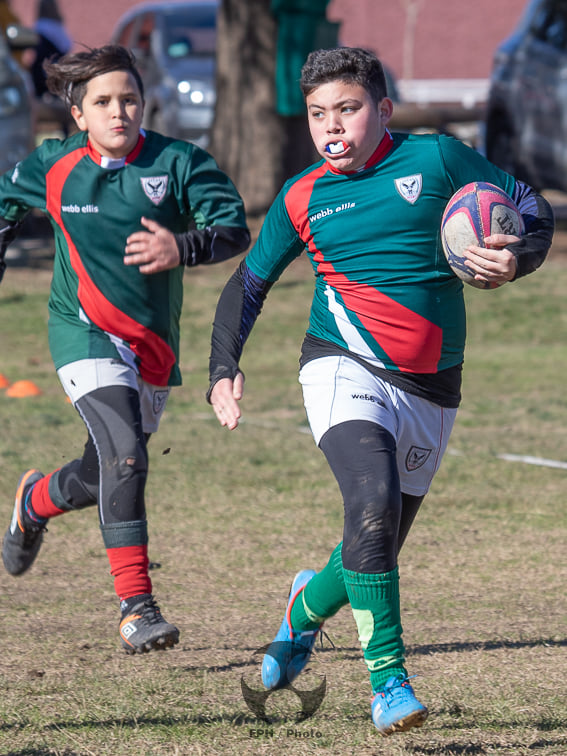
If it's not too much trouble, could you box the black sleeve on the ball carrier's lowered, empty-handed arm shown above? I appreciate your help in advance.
[207,260,273,402]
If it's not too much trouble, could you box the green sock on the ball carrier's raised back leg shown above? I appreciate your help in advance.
[290,543,348,630]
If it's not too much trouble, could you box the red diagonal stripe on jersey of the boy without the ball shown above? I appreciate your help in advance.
[46,147,175,386]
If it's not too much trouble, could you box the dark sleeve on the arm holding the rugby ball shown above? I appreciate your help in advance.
[506,181,555,278]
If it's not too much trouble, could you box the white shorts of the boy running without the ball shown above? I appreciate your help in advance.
[57,357,170,433]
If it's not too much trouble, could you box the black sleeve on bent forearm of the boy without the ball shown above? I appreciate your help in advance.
[175,226,250,267]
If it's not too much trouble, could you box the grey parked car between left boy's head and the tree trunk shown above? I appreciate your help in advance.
[112,0,219,147]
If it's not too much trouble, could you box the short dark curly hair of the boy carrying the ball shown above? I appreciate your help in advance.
[299,47,388,104]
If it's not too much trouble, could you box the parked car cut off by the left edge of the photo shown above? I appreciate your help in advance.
[0,26,35,173]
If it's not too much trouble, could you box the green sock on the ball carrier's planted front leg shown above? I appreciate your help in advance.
[344,567,406,691]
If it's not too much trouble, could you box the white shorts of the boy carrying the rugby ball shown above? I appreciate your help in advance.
[299,356,457,496]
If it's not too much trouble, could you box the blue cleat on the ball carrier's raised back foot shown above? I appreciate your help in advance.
[262,570,321,690]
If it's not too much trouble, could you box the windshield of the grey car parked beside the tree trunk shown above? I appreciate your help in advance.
[164,6,217,58]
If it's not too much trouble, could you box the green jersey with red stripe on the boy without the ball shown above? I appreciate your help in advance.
[0,132,246,385]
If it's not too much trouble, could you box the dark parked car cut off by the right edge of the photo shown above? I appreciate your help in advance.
[485,0,567,191]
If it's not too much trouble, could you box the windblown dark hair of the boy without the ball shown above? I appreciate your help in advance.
[43,45,144,108]
